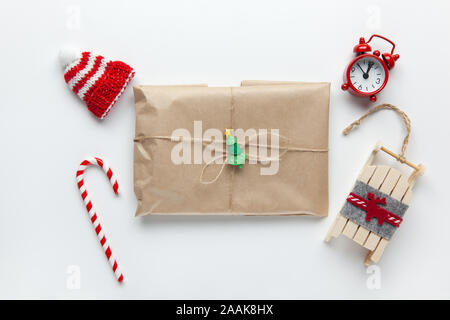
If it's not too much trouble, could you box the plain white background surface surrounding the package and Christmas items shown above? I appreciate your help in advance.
[0,0,450,299]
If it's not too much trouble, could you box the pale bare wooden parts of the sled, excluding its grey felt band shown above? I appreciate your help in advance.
[325,142,425,265]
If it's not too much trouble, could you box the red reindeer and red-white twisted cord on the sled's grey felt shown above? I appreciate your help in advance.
[347,192,403,228]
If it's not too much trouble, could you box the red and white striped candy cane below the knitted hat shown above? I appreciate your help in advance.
[77,157,123,282]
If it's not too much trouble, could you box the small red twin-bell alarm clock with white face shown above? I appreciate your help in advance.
[341,34,400,101]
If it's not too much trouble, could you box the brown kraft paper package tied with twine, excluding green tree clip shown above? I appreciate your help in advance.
[134,81,330,216]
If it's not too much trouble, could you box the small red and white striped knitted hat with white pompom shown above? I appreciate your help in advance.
[60,49,134,119]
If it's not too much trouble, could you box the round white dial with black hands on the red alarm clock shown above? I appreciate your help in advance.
[349,57,386,94]
